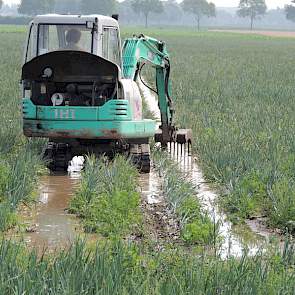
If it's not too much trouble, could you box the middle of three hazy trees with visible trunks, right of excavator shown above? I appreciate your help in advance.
[181,0,216,31]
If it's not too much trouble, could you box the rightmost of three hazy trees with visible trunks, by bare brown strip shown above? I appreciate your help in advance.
[237,0,267,30]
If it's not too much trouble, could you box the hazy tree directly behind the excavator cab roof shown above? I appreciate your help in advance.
[81,0,116,15]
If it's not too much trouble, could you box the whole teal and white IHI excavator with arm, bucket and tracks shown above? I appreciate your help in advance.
[21,14,192,173]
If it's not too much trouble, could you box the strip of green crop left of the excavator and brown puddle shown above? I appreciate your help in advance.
[0,33,43,231]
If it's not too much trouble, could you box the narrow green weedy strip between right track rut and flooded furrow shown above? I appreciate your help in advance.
[153,150,218,245]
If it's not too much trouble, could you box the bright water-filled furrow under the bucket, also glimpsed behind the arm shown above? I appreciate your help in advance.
[138,82,280,258]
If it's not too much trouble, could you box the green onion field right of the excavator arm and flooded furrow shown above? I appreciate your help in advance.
[131,27,295,232]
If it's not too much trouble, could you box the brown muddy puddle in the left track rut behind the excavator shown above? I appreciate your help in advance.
[23,157,83,249]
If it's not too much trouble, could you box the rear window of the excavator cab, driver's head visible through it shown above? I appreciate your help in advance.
[37,24,93,55]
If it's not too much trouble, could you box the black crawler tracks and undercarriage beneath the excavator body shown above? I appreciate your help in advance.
[43,139,151,173]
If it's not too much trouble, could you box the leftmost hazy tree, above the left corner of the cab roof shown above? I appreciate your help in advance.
[18,0,55,15]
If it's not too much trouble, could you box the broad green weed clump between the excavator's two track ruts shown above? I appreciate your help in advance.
[70,156,141,237]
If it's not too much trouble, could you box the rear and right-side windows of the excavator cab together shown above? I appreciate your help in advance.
[24,23,122,67]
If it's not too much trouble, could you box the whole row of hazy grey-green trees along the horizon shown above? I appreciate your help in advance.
[0,0,295,30]
